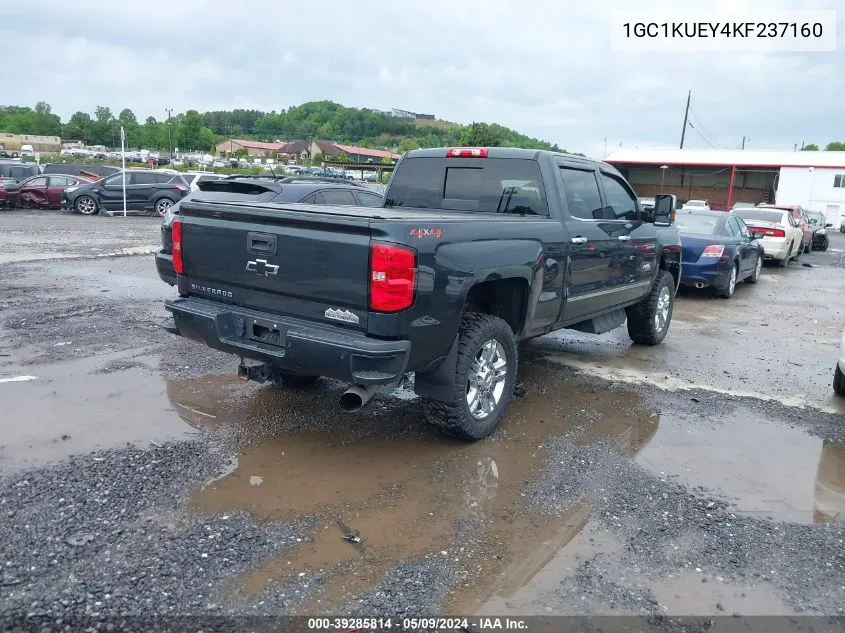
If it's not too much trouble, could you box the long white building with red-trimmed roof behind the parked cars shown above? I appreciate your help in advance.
[604,148,845,226]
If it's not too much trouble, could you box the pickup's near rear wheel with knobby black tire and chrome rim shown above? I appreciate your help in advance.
[422,312,518,441]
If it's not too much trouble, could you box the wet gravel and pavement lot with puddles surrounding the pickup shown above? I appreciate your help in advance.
[0,214,845,616]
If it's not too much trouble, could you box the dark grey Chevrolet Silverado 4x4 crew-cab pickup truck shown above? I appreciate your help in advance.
[166,148,681,440]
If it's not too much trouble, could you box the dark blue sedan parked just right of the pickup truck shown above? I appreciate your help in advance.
[675,210,764,299]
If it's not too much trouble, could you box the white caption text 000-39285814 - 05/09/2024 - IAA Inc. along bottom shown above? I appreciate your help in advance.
[308,617,528,633]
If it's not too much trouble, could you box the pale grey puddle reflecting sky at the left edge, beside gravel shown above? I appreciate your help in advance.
[0,350,192,470]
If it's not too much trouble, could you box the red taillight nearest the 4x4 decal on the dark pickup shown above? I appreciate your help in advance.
[370,244,417,312]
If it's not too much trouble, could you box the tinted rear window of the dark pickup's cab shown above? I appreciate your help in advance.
[385,157,549,216]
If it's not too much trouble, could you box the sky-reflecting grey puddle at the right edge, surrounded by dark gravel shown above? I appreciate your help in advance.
[637,408,845,523]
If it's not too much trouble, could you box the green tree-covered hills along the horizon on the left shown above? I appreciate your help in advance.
[0,101,580,153]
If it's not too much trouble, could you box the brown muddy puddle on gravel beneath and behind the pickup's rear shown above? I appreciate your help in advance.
[169,365,658,614]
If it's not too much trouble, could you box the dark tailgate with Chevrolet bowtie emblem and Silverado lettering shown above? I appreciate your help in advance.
[180,202,370,328]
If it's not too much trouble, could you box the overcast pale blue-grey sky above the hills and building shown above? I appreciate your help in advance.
[0,0,845,157]
